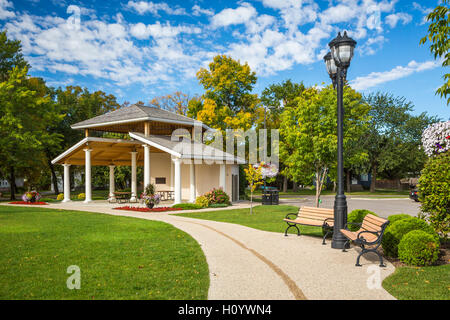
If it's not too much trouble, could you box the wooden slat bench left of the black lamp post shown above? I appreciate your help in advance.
[284,207,334,244]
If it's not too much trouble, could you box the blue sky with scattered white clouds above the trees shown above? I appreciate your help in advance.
[0,0,450,119]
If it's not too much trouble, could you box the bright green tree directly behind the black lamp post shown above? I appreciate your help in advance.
[280,86,369,206]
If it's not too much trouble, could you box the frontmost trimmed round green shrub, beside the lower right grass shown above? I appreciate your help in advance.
[398,230,439,266]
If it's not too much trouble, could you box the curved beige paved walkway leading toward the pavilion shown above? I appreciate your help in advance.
[0,202,395,300]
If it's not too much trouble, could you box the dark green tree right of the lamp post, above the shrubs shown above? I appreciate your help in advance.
[363,92,436,192]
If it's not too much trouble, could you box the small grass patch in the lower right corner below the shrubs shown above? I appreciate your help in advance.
[383,265,450,300]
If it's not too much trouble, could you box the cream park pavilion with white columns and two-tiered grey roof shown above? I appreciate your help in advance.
[52,105,245,204]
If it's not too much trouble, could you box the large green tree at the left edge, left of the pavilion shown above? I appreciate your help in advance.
[0,67,63,200]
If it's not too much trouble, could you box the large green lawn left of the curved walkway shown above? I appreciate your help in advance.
[0,206,209,299]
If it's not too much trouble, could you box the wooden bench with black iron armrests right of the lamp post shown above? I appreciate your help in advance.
[340,214,389,267]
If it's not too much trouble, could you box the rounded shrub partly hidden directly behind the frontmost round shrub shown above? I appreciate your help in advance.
[381,217,439,258]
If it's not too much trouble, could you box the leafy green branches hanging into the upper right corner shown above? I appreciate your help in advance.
[420,0,450,105]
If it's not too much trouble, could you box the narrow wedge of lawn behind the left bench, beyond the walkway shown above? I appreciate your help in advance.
[177,205,322,236]
